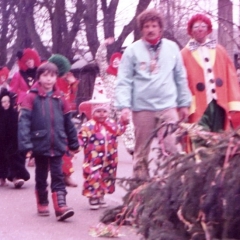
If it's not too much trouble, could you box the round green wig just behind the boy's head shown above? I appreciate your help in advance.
[48,54,71,77]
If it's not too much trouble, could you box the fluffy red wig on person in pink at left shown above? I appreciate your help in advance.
[17,48,41,71]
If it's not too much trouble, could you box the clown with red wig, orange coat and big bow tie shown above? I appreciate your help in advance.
[181,14,240,132]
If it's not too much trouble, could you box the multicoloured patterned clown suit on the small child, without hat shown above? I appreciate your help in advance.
[79,119,126,198]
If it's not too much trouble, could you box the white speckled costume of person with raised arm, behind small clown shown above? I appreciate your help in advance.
[96,44,135,153]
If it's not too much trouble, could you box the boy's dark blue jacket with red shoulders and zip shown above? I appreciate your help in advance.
[18,82,79,157]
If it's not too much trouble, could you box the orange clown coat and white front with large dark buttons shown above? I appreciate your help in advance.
[182,40,240,129]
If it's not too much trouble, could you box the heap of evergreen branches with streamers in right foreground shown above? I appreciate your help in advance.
[101,124,240,240]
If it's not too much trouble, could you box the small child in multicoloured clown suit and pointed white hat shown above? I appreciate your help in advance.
[79,81,128,210]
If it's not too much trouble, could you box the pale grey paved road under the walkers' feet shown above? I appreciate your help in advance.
[0,141,140,240]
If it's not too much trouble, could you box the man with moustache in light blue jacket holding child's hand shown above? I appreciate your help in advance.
[115,10,191,179]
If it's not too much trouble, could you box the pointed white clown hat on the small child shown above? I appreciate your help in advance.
[79,77,110,118]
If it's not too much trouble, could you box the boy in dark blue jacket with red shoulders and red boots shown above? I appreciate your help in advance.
[18,62,79,221]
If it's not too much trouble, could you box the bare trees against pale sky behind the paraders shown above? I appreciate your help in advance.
[0,0,239,67]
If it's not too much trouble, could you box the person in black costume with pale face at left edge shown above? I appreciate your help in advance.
[0,87,30,188]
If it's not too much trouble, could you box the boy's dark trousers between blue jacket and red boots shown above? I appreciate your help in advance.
[34,154,67,193]
